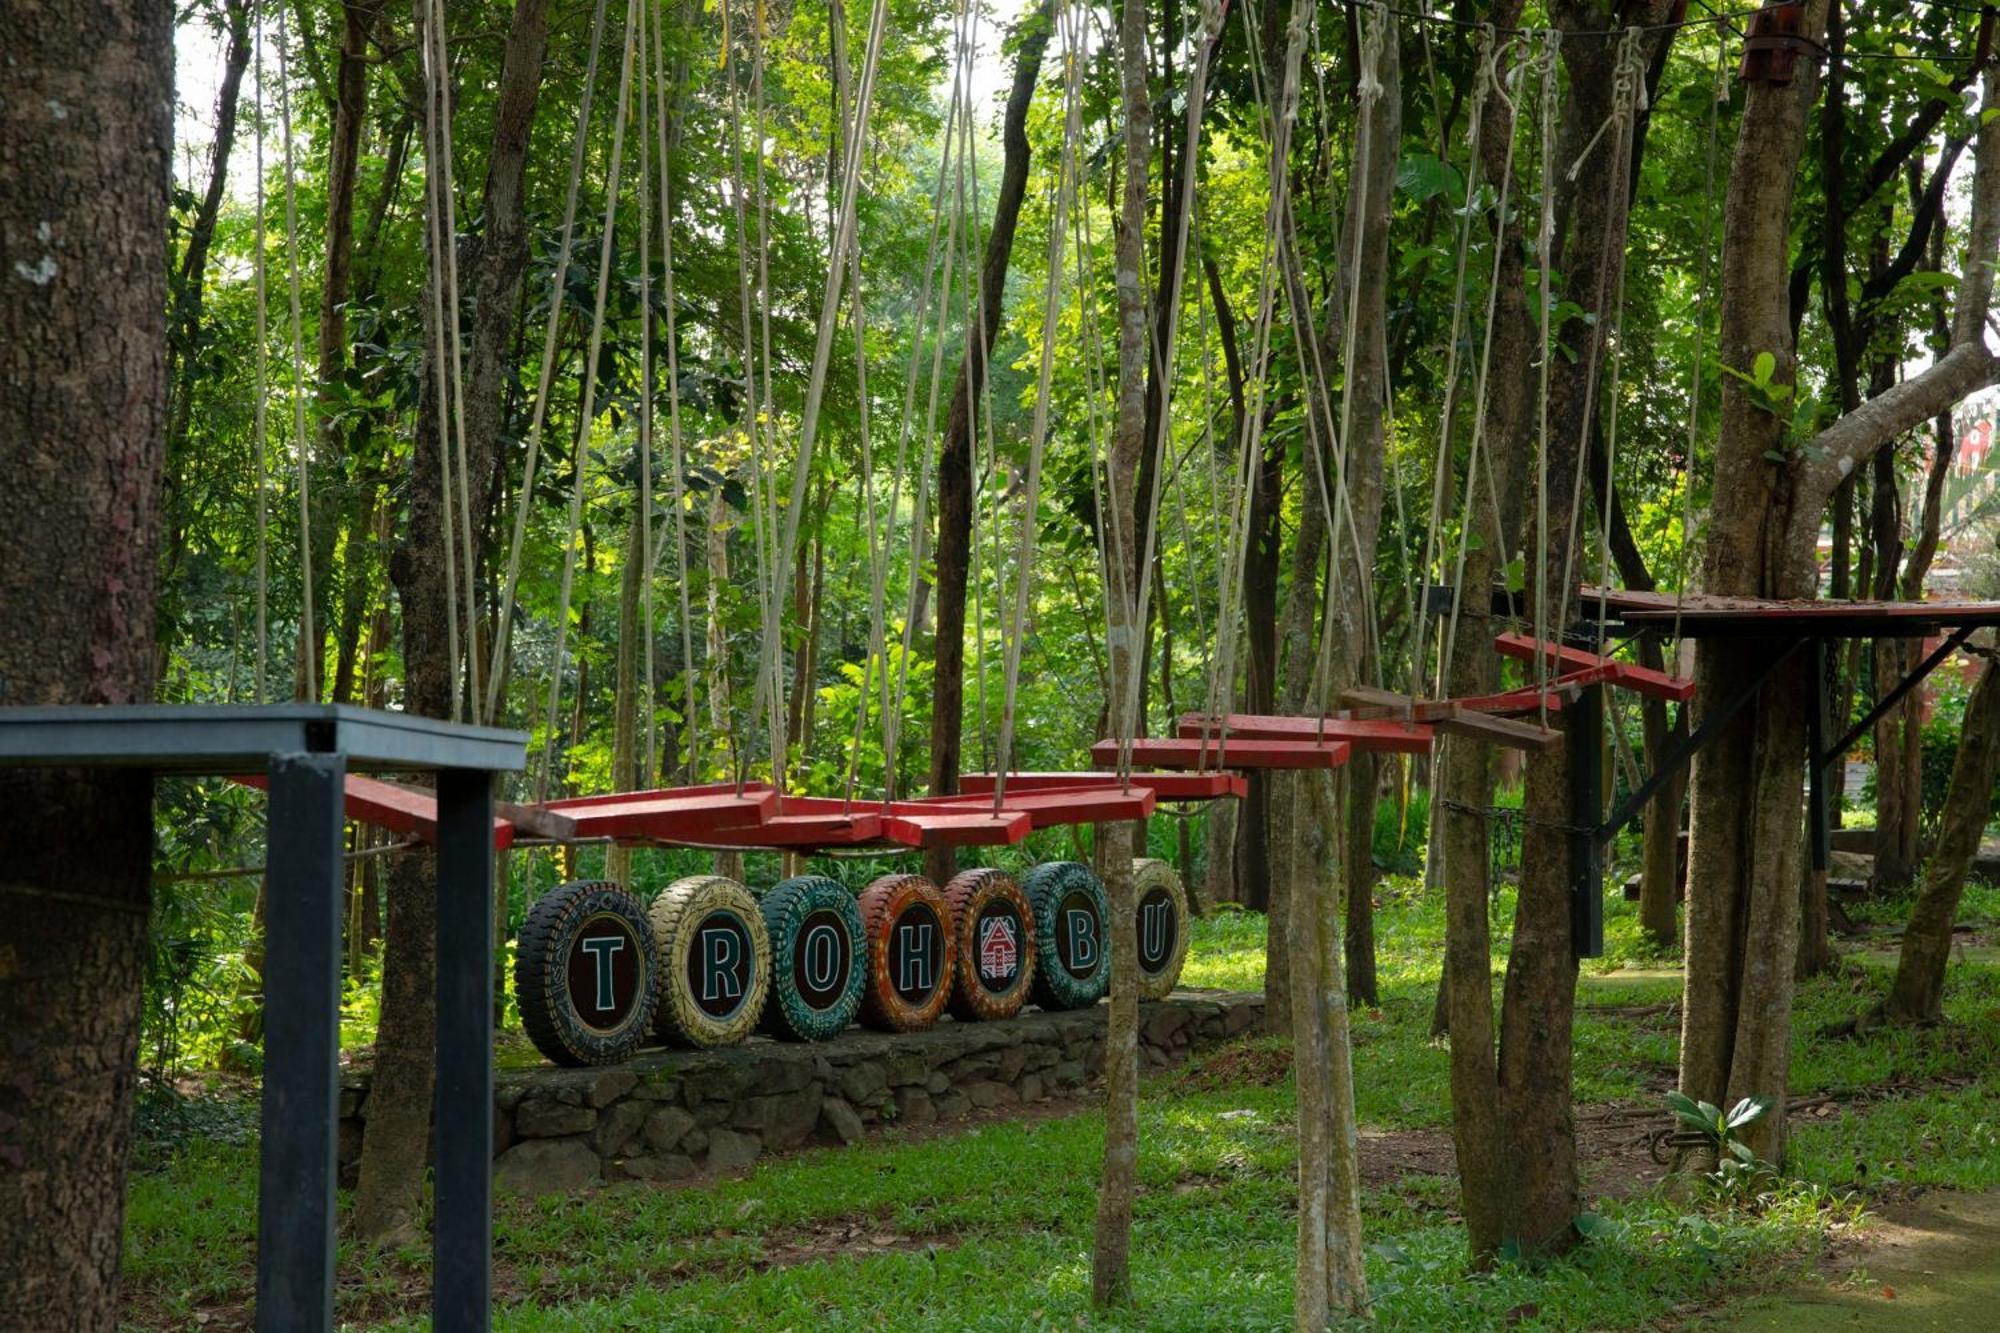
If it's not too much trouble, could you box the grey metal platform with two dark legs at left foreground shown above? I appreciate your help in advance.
[0,705,528,1331]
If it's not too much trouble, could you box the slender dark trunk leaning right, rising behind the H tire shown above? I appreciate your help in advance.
[924,0,1054,885]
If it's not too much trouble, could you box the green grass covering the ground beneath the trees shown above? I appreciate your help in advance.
[126,879,2000,1329]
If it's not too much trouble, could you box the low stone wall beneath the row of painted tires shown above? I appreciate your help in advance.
[340,991,1264,1193]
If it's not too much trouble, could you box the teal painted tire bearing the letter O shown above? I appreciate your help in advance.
[760,875,868,1041]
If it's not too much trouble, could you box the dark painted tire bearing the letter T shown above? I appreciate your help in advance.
[514,881,658,1065]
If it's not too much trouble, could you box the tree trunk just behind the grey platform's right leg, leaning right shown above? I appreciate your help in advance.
[354,0,548,1245]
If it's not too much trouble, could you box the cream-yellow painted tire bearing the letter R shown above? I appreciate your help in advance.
[650,875,770,1047]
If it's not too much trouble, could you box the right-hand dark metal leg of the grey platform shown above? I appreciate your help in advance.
[430,769,494,1333]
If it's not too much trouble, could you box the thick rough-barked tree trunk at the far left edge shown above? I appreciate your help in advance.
[0,0,174,1329]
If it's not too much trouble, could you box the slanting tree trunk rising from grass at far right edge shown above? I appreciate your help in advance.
[1882,658,2000,1023]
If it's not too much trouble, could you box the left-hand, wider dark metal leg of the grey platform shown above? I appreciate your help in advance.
[256,755,348,1333]
